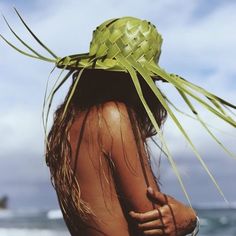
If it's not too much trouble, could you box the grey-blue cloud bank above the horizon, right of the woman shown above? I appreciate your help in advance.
[157,155,236,204]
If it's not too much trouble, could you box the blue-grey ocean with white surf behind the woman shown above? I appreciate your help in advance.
[0,208,236,236]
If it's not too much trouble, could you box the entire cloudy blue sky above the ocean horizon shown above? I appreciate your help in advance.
[0,0,236,208]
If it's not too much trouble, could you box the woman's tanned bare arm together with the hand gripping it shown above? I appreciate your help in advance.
[102,102,196,235]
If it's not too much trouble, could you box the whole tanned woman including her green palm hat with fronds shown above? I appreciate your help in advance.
[1,10,236,236]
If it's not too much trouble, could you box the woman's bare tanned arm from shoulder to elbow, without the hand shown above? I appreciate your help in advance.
[102,102,160,212]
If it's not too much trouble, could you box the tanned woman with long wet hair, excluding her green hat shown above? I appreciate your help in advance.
[47,70,196,236]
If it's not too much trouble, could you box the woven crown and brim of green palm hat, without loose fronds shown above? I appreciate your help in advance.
[57,17,162,77]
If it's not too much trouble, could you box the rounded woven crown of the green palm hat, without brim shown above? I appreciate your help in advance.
[89,17,162,63]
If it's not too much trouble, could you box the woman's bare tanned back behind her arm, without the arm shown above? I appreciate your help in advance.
[69,105,129,236]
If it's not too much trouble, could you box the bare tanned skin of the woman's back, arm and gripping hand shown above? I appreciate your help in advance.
[69,102,195,236]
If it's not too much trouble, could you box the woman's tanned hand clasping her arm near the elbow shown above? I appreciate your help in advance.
[130,188,196,236]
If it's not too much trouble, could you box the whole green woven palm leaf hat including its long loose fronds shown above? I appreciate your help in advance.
[0,9,236,205]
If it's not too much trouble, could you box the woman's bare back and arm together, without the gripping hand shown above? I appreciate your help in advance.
[68,102,160,236]
